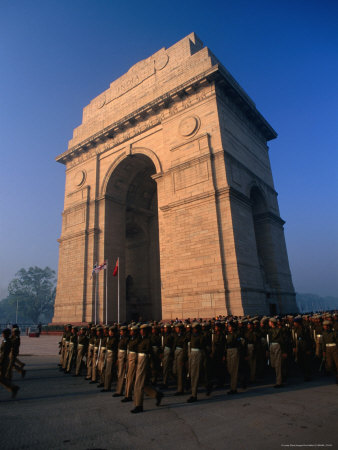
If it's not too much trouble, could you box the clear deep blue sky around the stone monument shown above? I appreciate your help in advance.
[0,0,338,296]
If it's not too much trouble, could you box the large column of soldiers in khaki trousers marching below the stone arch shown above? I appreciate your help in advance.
[59,313,338,413]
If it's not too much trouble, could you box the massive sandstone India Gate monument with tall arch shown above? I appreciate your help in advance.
[53,33,297,323]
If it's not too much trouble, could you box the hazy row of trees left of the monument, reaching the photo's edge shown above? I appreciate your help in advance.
[0,266,56,324]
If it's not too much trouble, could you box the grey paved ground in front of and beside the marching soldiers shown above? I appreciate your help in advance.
[0,336,338,450]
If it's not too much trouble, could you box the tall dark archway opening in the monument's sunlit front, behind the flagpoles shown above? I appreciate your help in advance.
[105,154,161,321]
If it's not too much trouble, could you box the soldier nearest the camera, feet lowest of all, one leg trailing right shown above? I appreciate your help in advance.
[131,324,163,414]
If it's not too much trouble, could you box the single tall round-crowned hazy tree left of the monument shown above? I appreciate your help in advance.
[8,266,56,323]
